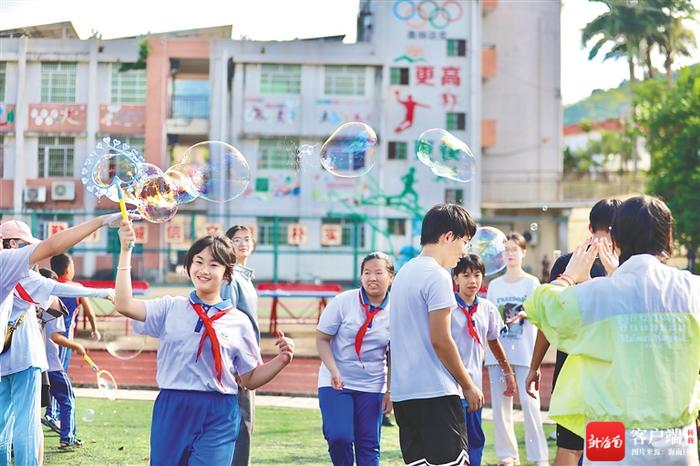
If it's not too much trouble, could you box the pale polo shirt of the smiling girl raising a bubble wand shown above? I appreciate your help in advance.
[133,296,262,395]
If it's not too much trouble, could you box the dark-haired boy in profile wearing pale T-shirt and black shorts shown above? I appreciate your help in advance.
[390,204,484,465]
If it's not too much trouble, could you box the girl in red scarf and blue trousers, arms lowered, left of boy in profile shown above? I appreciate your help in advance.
[316,252,394,466]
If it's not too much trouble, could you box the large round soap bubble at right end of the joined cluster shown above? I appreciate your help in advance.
[180,141,250,202]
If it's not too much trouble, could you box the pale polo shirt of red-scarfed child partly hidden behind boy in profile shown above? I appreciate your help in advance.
[451,298,503,390]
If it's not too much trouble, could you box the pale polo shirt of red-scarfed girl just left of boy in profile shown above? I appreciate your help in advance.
[316,289,389,393]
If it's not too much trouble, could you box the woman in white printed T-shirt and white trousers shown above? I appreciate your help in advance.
[486,233,549,466]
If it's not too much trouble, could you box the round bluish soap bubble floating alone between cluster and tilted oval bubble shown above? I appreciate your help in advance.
[321,121,377,178]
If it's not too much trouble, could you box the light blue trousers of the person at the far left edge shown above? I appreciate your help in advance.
[0,367,43,466]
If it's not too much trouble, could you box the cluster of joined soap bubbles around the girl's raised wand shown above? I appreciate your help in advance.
[81,137,250,223]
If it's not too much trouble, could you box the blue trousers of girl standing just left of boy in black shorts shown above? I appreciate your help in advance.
[318,387,384,466]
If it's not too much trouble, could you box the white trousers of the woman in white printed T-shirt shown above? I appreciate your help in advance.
[488,366,549,464]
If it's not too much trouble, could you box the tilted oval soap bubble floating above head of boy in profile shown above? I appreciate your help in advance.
[416,128,476,183]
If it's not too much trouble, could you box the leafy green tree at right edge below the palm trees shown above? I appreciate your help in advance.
[635,65,700,270]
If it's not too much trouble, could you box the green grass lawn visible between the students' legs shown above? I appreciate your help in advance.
[44,398,555,466]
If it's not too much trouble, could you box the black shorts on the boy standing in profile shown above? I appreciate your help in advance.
[394,395,468,466]
